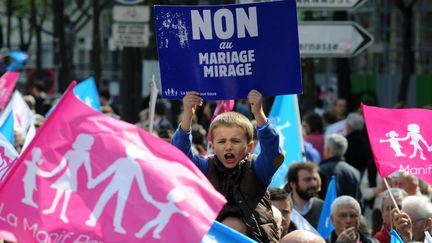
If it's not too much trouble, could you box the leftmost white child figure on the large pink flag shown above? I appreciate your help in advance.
[21,147,62,208]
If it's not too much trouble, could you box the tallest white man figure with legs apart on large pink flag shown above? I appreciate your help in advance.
[86,144,151,234]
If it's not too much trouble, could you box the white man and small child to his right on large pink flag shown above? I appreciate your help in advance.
[80,144,188,239]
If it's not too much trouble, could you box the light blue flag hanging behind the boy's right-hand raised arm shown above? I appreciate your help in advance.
[269,95,304,188]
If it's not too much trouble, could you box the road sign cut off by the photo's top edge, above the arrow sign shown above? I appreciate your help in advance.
[297,0,367,10]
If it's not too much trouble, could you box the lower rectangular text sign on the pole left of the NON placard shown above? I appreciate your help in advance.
[112,23,150,47]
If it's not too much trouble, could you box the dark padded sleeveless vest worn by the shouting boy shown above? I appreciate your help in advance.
[207,155,279,243]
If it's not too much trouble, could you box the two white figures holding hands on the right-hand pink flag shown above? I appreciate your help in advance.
[380,123,432,160]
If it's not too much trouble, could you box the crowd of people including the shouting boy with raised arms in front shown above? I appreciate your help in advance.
[10,81,432,243]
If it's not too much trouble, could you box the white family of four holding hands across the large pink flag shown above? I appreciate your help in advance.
[22,134,188,238]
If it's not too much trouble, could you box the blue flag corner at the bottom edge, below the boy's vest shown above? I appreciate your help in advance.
[202,221,256,243]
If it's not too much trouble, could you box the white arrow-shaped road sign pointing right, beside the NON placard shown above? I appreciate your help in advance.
[298,21,374,57]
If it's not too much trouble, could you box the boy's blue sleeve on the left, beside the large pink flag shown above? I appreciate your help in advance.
[171,127,208,174]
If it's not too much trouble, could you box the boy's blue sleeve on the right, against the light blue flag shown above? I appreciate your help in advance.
[253,123,284,187]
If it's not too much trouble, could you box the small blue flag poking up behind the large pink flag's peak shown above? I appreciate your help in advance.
[74,76,101,111]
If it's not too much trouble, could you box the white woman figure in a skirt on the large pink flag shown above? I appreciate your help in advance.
[43,133,94,223]
